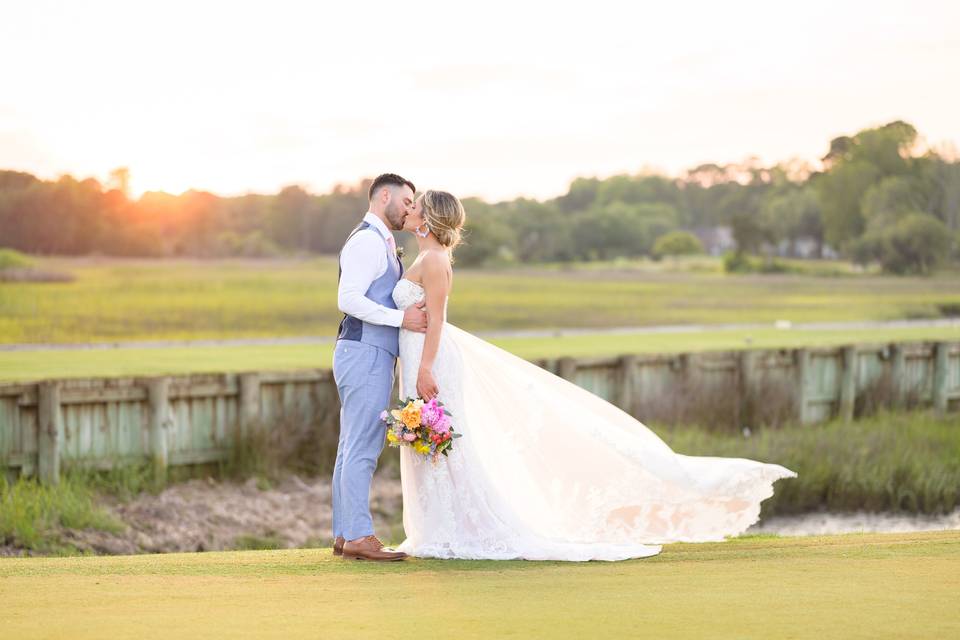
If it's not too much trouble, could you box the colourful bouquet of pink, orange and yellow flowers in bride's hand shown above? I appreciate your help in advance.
[380,398,460,462]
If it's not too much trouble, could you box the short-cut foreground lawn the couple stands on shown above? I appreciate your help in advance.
[0,531,960,640]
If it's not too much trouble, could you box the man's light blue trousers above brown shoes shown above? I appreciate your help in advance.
[333,340,396,540]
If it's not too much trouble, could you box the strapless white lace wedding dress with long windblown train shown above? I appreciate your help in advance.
[393,280,797,560]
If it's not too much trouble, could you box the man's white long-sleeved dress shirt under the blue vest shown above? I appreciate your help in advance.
[337,211,403,327]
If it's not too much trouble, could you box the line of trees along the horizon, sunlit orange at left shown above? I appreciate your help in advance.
[0,121,960,273]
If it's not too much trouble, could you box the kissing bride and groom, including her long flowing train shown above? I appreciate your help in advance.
[333,173,797,561]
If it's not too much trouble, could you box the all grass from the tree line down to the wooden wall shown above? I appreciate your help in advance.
[0,257,960,380]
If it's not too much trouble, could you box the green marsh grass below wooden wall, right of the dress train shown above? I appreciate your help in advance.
[656,411,960,519]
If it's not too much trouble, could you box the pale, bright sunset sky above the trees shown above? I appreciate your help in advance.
[0,0,960,200]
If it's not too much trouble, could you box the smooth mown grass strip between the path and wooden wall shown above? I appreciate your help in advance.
[0,327,960,380]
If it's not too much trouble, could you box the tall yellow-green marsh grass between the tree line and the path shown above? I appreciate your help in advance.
[0,257,960,343]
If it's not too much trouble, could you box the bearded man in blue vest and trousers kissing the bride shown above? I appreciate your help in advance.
[333,173,427,560]
